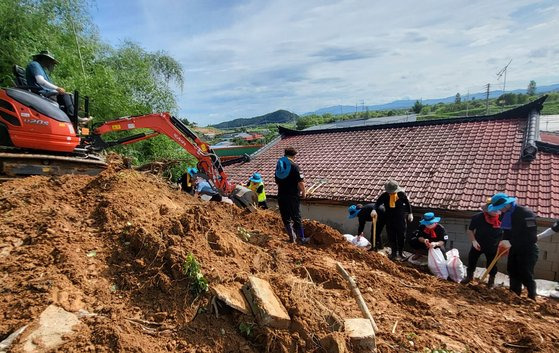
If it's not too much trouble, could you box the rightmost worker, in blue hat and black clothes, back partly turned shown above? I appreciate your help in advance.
[487,193,539,300]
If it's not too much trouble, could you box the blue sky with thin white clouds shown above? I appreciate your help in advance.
[91,0,559,125]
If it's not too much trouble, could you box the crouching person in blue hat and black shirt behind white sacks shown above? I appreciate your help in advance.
[409,212,448,255]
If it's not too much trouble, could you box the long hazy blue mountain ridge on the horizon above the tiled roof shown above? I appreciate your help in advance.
[303,84,559,116]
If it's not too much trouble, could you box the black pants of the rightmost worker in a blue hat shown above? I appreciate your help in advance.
[507,244,540,299]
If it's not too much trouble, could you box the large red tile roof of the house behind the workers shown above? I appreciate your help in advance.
[227,100,559,218]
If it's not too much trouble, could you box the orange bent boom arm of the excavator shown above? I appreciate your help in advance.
[85,113,248,194]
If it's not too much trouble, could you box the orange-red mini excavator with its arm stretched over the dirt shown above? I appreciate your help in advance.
[0,66,255,206]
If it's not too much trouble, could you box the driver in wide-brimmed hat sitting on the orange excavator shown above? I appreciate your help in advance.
[25,50,80,124]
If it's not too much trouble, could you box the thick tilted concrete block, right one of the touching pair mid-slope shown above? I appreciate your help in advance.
[243,276,291,329]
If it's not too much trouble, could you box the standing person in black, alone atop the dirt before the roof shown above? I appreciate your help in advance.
[275,147,309,244]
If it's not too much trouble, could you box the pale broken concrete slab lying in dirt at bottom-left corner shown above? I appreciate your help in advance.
[21,305,79,353]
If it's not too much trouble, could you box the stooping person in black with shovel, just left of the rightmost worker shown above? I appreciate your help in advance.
[462,204,503,288]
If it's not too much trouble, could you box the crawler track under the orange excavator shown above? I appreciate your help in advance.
[0,148,107,181]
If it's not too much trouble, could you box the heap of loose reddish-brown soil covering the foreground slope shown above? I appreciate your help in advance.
[0,161,559,352]
